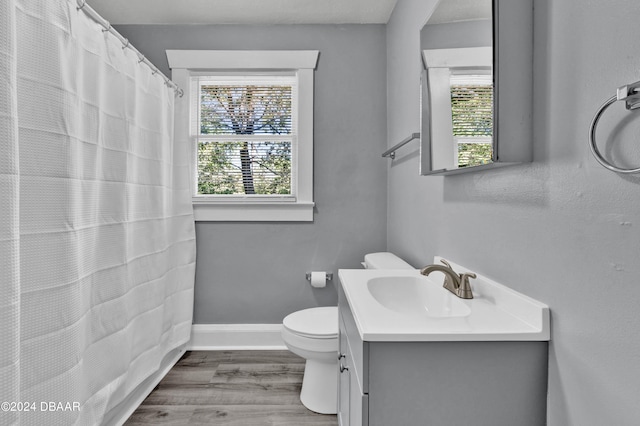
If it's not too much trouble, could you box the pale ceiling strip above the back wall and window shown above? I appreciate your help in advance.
[87,0,397,25]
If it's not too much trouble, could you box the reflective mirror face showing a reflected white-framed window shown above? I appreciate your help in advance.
[420,0,494,174]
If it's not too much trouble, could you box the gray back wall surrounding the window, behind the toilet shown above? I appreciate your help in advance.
[117,25,387,324]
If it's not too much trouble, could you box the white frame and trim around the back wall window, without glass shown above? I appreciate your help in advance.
[166,50,319,222]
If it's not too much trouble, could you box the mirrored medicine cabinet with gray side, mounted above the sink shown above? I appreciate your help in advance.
[420,0,533,175]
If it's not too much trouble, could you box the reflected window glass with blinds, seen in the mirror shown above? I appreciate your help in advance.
[451,75,493,167]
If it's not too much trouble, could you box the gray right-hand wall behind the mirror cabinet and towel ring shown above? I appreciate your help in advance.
[387,0,640,426]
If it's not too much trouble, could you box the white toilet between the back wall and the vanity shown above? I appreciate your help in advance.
[282,252,415,414]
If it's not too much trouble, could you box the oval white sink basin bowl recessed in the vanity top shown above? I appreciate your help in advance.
[367,277,471,318]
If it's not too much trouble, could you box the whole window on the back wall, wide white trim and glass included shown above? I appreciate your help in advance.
[167,50,318,221]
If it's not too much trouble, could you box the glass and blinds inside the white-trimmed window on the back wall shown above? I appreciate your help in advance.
[197,78,295,196]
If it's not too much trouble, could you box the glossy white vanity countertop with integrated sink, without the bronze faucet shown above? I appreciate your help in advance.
[338,256,550,342]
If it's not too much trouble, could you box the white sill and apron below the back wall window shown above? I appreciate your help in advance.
[193,200,315,222]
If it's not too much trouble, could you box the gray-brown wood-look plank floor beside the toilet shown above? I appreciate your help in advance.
[125,351,338,426]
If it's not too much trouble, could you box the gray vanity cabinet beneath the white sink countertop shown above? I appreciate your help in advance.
[338,285,548,426]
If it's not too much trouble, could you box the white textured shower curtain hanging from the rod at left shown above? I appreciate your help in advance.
[0,0,195,426]
